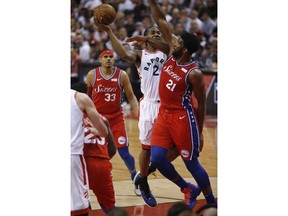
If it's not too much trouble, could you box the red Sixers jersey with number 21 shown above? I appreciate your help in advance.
[159,55,198,110]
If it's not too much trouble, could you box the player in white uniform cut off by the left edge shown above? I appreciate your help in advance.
[70,89,108,216]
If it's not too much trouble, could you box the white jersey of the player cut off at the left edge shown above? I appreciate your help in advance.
[70,89,84,154]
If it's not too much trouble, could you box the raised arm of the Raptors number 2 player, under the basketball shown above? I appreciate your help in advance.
[94,19,139,63]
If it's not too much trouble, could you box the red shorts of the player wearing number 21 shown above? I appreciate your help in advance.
[151,108,200,160]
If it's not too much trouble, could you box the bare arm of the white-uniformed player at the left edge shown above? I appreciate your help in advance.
[76,92,108,137]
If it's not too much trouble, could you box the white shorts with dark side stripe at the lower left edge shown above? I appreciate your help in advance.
[71,155,90,212]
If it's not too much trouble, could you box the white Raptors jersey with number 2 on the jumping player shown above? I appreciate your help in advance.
[137,49,167,101]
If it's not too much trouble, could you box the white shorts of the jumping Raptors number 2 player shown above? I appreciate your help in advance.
[138,99,160,146]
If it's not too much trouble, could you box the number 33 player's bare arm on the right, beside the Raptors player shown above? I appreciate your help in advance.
[121,71,138,116]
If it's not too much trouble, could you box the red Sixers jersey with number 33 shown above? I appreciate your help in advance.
[92,67,123,120]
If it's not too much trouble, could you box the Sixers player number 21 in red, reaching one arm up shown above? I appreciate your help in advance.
[145,0,216,209]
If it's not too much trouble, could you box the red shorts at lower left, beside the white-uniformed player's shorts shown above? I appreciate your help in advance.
[85,157,115,212]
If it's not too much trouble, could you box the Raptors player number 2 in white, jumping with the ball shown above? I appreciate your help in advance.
[94,20,179,207]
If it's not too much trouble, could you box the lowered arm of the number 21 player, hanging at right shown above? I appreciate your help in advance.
[189,69,206,151]
